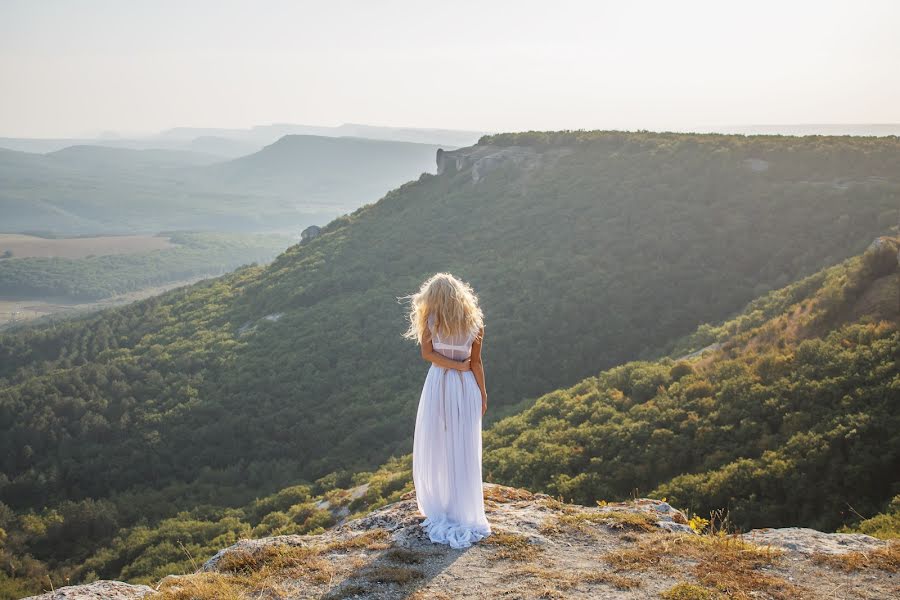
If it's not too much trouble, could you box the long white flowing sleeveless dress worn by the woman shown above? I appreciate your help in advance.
[413,315,491,548]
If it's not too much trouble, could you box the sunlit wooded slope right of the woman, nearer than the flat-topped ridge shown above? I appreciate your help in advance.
[484,238,900,530]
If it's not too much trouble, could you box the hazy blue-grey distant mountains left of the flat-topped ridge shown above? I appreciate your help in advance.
[0,135,450,234]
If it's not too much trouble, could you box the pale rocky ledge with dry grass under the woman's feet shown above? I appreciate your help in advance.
[24,483,900,600]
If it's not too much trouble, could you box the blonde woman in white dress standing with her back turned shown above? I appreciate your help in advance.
[403,273,491,548]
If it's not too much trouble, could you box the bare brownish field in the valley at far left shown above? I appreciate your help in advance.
[0,233,174,258]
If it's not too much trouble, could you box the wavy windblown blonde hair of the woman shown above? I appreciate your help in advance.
[398,273,484,344]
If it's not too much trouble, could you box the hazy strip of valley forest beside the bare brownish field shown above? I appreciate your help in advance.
[0,231,291,302]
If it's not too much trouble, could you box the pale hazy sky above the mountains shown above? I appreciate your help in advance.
[0,0,900,137]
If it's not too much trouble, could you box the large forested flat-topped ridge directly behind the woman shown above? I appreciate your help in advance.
[0,132,900,520]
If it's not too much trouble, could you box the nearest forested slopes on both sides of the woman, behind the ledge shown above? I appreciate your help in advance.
[0,238,900,598]
